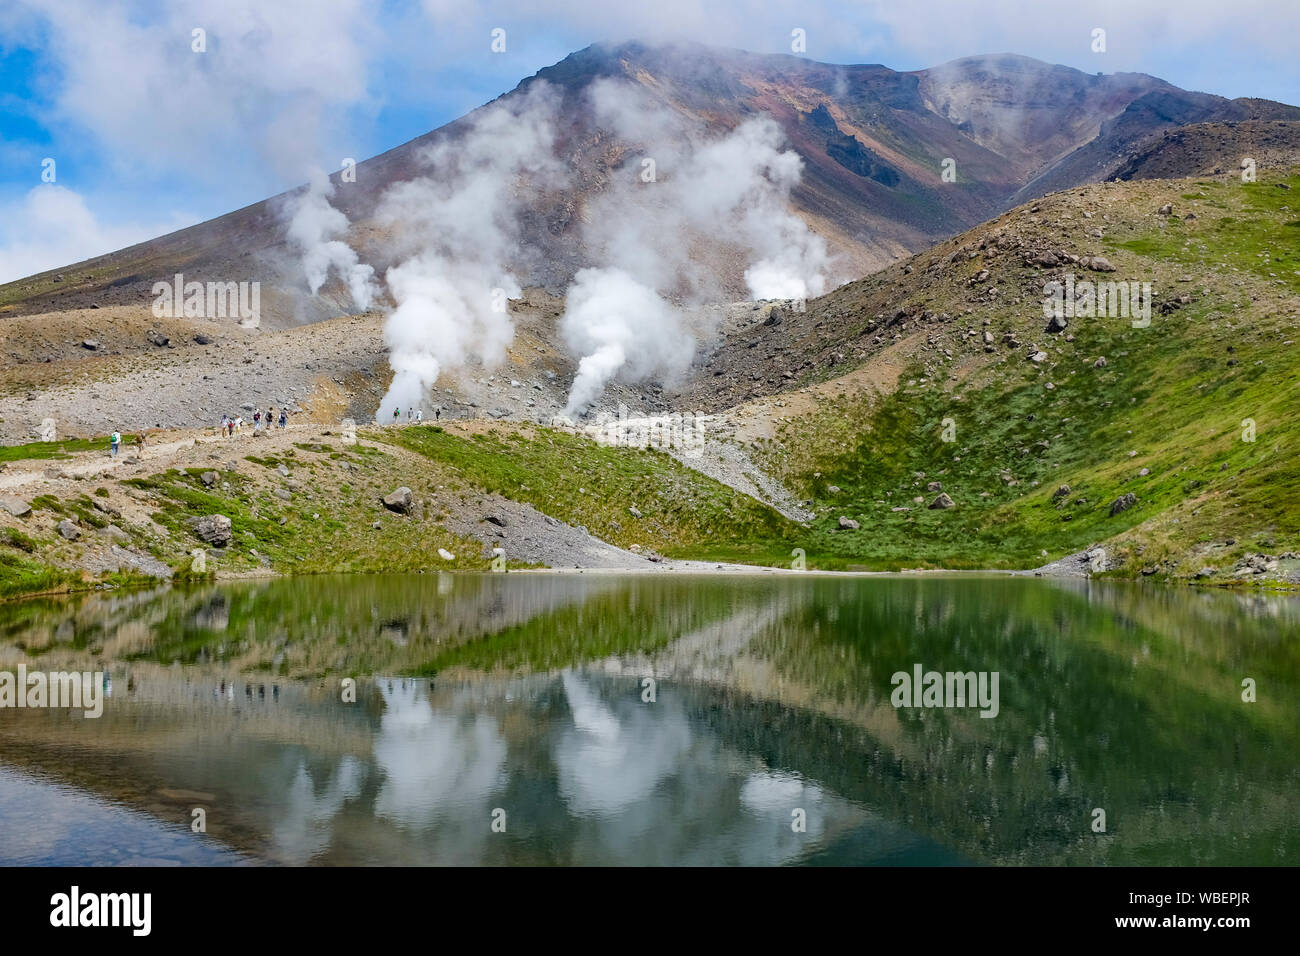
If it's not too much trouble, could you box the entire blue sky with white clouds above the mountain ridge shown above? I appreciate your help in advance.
[0,0,1300,281]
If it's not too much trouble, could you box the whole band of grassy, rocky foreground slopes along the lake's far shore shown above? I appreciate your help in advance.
[0,166,1300,589]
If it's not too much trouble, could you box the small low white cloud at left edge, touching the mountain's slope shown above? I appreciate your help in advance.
[0,183,194,282]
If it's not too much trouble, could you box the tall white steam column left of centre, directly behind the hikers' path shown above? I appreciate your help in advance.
[376,83,563,423]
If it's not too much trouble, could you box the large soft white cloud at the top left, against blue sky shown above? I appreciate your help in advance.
[25,0,382,181]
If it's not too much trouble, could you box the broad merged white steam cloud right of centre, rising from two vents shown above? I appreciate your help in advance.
[560,81,829,416]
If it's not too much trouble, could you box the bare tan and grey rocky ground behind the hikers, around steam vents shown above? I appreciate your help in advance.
[0,291,748,444]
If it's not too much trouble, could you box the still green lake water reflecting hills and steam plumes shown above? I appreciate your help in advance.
[0,574,1300,865]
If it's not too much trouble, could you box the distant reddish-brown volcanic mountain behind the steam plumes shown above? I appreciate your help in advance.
[0,43,1300,328]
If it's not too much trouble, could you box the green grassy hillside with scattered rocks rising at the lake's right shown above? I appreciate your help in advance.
[766,176,1300,580]
